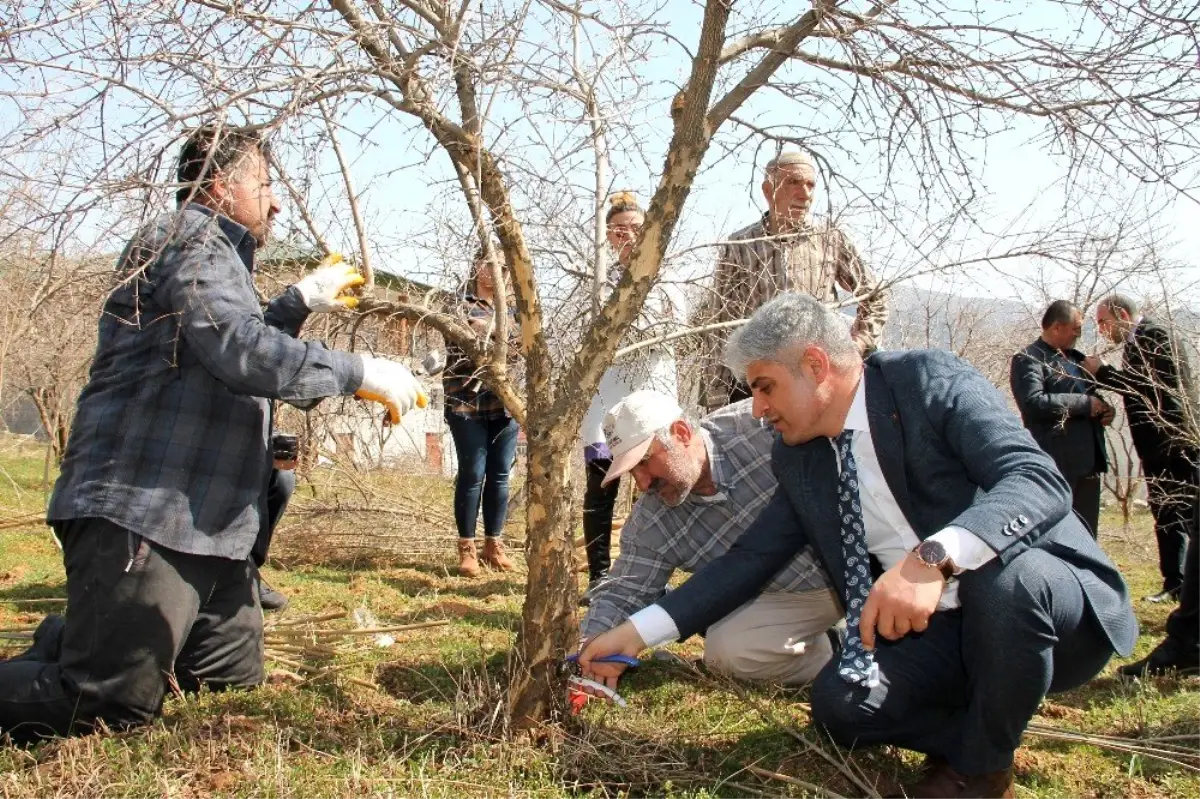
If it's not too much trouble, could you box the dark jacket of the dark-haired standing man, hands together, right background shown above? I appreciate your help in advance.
[1008,338,1108,482]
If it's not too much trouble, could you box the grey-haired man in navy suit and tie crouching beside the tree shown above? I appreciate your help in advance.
[581,294,1138,799]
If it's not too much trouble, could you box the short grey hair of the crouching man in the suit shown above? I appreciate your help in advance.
[725,294,862,377]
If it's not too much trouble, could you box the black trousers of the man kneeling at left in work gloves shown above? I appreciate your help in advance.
[0,518,263,740]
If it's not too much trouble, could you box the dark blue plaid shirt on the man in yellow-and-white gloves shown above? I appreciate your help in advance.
[48,204,362,559]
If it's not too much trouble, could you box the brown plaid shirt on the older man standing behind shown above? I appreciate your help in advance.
[692,214,888,409]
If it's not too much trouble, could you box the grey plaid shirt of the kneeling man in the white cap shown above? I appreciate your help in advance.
[581,400,829,638]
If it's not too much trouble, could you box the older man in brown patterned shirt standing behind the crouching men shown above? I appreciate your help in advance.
[692,150,888,410]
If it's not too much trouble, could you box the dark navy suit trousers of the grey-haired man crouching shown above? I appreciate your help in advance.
[812,549,1112,775]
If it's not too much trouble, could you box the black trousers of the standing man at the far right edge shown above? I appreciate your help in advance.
[1141,455,1196,590]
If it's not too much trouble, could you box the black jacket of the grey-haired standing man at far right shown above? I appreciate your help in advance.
[1096,317,1195,463]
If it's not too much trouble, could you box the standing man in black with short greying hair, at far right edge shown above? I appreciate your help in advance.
[1084,294,1200,602]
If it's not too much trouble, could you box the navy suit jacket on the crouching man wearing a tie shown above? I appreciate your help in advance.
[659,350,1138,655]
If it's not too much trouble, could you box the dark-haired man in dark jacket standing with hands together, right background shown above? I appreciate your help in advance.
[1008,300,1114,537]
